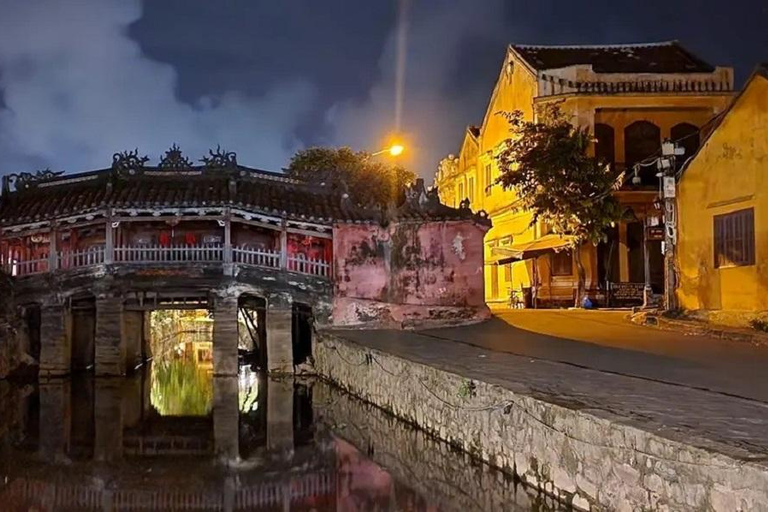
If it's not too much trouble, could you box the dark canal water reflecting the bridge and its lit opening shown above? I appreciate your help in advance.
[0,361,555,512]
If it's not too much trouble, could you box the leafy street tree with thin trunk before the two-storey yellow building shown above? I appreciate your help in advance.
[497,105,622,307]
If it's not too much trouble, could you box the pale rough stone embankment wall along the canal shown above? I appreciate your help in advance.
[314,333,768,512]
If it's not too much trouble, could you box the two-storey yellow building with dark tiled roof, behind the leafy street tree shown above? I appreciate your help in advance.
[435,42,733,306]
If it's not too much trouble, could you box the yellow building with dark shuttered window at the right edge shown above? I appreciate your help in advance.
[677,65,768,323]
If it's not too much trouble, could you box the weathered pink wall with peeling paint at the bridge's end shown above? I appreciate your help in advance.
[333,220,487,324]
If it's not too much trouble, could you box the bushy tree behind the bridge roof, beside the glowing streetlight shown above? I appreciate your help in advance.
[287,147,416,206]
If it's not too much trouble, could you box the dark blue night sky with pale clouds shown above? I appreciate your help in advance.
[0,0,768,177]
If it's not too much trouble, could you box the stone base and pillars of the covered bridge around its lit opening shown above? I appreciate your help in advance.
[11,268,331,376]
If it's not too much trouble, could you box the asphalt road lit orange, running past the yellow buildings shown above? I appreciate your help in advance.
[419,310,768,403]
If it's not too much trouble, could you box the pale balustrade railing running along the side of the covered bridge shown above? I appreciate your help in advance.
[0,245,332,278]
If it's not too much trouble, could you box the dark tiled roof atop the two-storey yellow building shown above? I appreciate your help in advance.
[511,41,714,73]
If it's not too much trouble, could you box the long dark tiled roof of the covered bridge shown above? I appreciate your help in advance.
[0,166,374,225]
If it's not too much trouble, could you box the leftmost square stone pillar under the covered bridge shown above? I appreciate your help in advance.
[40,303,72,377]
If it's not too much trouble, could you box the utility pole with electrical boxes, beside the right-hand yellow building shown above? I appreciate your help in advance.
[657,140,685,311]
